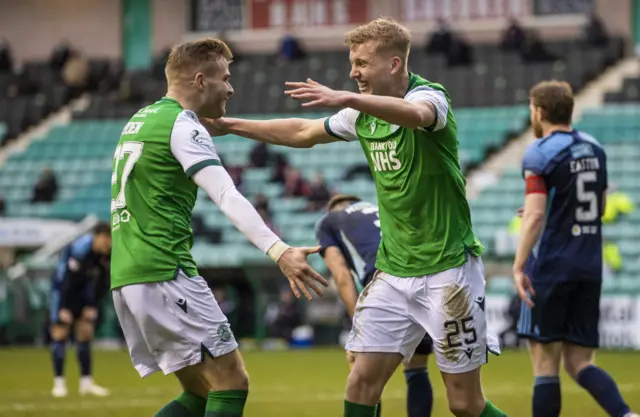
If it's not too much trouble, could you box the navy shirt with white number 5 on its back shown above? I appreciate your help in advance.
[523,131,607,282]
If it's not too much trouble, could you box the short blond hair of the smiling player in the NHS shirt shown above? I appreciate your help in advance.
[344,17,411,59]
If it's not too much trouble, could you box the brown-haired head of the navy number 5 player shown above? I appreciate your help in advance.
[529,80,573,125]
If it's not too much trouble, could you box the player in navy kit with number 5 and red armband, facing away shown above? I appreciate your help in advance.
[513,81,638,417]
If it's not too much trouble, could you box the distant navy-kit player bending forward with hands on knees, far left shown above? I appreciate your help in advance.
[50,224,111,398]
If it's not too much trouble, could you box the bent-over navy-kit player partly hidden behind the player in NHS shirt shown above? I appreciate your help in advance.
[316,195,433,417]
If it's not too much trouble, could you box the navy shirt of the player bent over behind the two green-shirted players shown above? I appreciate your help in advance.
[316,202,380,285]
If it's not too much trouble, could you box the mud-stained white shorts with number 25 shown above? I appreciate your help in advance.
[346,256,500,374]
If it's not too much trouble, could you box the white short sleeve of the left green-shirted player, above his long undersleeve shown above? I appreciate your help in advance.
[171,110,222,177]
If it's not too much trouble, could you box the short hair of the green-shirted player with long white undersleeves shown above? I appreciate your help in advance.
[165,38,233,79]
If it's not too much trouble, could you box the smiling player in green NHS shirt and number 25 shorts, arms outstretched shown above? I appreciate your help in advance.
[205,19,504,417]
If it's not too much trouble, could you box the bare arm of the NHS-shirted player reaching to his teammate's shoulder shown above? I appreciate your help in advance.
[201,118,340,148]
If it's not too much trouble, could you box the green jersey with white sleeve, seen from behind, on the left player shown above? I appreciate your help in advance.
[111,98,220,289]
